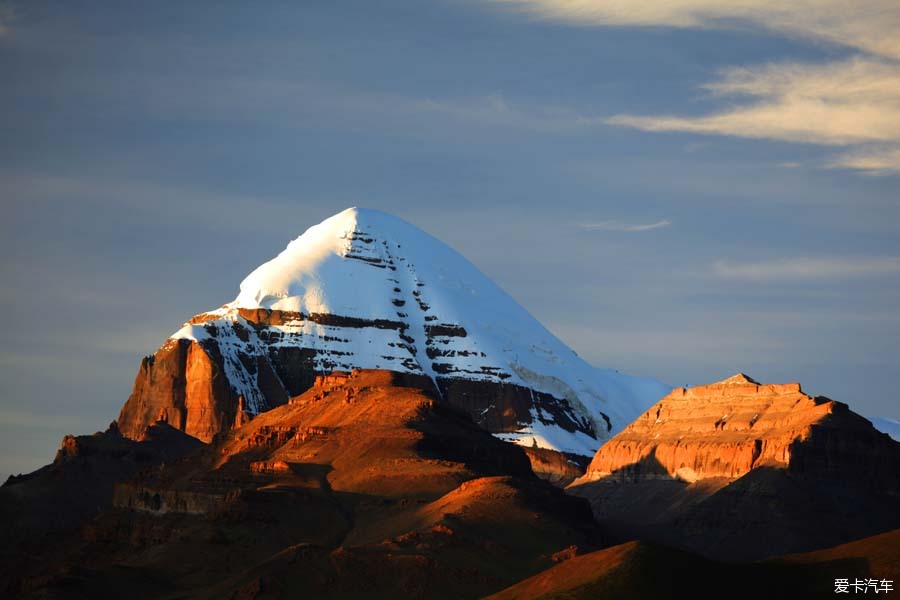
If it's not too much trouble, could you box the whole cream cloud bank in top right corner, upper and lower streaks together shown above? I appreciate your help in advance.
[495,0,900,175]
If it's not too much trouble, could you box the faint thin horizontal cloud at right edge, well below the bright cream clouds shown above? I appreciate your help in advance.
[712,257,900,281]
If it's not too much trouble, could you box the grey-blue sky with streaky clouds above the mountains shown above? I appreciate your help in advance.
[0,0,900,475]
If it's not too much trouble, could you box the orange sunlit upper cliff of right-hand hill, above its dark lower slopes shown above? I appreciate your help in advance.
[581,374,897,486]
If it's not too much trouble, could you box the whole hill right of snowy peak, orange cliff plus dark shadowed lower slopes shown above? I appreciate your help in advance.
[569,374,900,560]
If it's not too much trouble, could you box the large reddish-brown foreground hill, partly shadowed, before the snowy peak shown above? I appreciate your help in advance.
[7,371,604,598]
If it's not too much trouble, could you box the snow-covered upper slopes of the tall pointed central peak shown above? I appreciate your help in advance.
[162,208,670,456]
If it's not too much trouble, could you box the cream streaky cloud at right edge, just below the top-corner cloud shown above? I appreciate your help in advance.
[608,59,900,173]
